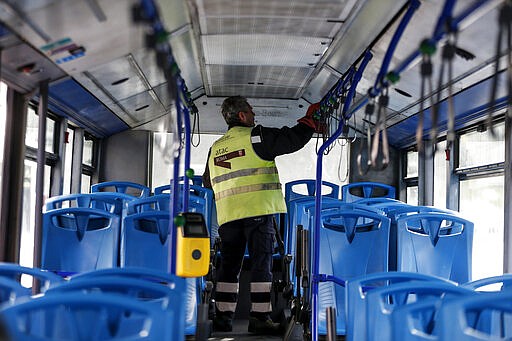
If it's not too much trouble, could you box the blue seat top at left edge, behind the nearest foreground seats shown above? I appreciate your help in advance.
[0,263,64,294]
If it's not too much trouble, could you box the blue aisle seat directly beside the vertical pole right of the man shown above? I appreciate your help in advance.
[311,208,389,335]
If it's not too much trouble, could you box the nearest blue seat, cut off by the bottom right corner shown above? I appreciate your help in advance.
[438,290,512,341]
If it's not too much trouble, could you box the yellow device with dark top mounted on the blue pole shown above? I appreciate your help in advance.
[175,212,210,277]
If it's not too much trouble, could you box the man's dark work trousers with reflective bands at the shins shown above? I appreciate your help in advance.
[215,215,275,319]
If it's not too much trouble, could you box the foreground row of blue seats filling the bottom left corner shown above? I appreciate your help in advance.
[0,263,187,341]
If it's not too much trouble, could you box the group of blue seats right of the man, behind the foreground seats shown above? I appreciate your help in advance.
[286,180,473,335]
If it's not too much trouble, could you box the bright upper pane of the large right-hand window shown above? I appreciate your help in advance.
[459,123,505,168]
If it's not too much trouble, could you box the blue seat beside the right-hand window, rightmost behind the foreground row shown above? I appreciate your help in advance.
[397,212,473,283]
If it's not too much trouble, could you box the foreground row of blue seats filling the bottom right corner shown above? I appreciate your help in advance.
[345,272,512,341]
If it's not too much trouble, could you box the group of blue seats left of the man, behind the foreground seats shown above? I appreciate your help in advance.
[41,182,213,335]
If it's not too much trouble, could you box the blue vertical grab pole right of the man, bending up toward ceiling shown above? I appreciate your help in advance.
[311,51,373,341]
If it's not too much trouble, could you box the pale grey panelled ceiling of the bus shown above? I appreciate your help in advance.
[0,0,502,145]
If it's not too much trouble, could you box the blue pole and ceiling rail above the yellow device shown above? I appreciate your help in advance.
[132,0,197,274]
